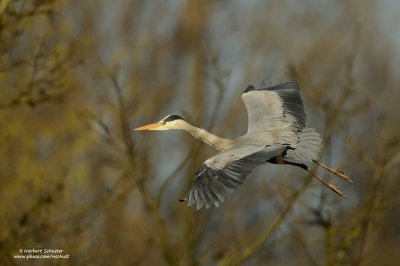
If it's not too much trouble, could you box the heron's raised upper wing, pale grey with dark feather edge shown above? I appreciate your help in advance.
[242,82,306,132]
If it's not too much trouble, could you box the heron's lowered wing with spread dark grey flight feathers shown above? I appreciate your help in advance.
[185,145,286,210]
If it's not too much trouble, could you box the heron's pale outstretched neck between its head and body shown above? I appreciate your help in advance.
[179,120,232,151]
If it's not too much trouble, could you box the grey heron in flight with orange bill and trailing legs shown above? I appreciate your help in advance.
[135,82,351,209]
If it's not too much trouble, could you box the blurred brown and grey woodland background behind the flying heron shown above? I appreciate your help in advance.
[0,0,400,265]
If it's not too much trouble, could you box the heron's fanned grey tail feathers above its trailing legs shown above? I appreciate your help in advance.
[284,128,322,163]
